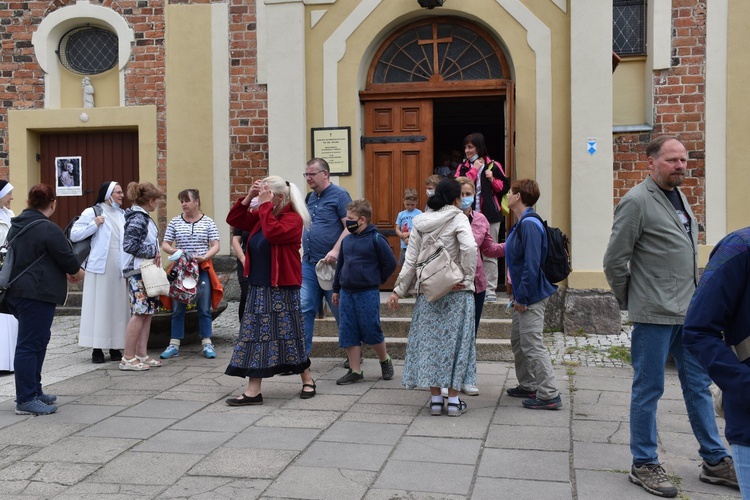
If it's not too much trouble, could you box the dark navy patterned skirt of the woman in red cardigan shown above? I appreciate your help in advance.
[224,286,310,378]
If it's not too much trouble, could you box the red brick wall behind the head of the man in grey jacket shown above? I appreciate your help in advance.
[613,0,706,242]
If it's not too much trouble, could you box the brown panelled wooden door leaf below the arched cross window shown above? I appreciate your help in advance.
[365,100,434,290]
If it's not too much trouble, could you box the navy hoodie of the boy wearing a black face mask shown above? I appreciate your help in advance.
[333,224,396,293]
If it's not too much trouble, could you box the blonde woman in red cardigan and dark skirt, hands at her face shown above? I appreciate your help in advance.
[225,176,316,406]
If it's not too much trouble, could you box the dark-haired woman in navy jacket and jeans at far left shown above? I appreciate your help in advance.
[3,184,84,415]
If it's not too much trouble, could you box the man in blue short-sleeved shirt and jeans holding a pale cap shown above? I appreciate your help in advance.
[300,158,352,356]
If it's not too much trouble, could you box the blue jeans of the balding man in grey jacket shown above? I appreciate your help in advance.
[630,323,729,466]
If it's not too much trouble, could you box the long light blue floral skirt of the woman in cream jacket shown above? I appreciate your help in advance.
[401,291,477,390]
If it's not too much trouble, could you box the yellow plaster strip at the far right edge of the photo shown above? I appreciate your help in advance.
[728,2,750,232]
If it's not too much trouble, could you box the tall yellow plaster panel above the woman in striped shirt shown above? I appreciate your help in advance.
[165,4,212,219]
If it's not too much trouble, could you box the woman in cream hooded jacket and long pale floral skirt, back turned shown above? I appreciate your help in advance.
[388,179,477,417]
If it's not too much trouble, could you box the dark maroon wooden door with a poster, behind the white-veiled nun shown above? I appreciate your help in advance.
[39,131,138,228]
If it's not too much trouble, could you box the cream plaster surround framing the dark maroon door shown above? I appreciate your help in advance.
[8,106,156,200]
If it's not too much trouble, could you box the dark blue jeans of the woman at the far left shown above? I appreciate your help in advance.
[6,297,55,404]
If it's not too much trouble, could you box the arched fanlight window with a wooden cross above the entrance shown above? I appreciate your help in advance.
[368,18,510,90]
